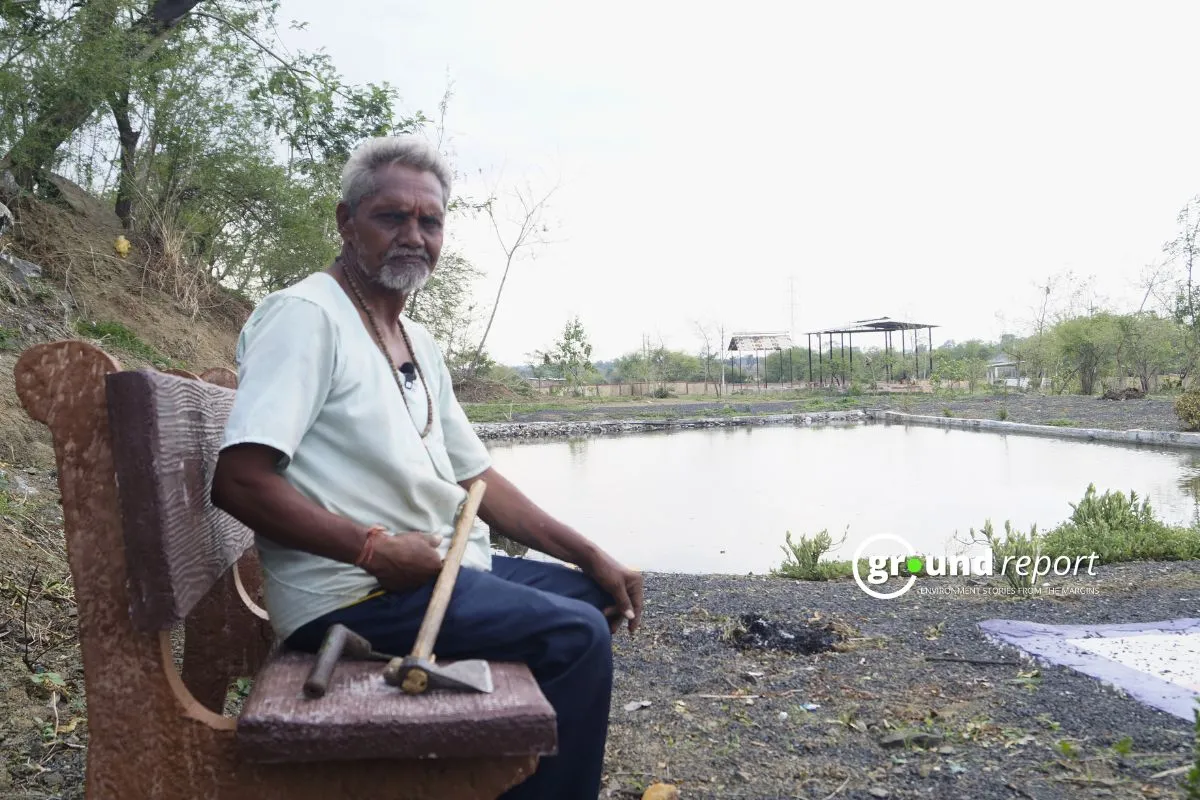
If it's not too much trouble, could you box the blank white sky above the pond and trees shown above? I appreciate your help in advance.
[281,0,1200,363]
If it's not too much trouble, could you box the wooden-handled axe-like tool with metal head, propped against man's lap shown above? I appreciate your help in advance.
[383,481,492,694]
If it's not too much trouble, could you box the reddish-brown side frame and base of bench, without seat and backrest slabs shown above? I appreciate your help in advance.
[14,342,547,800]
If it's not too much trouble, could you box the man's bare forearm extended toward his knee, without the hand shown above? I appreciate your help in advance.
[462,469,600,570]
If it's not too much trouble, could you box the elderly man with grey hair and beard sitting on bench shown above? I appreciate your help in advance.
[212,137,642,800]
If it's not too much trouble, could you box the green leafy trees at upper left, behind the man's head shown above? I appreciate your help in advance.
[0,0,441,311]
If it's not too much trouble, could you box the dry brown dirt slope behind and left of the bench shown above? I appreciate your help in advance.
[0,181,250,798]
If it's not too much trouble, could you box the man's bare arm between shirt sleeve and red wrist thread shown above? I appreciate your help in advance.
[212,449,366,564]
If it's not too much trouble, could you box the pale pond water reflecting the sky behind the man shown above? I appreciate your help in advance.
[487,423,1200,575]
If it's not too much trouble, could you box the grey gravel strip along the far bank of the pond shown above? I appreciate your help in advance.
[512,393,1182,431]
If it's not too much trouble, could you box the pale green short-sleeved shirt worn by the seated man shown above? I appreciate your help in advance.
[223,272,492,638]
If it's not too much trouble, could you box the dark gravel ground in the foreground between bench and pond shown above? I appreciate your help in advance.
[606,563,1200,800]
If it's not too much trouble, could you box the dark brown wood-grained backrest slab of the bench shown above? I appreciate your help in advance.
[106,371,253,631]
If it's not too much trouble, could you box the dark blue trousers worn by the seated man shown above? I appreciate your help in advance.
[287,555,613,800]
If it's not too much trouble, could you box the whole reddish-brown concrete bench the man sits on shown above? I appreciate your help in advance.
[14,342,557,800]
